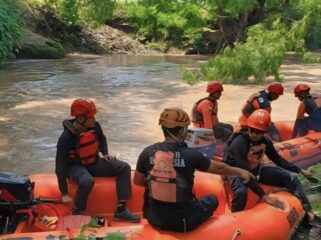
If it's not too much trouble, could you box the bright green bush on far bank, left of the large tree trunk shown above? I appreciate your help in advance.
[120,0,208,47]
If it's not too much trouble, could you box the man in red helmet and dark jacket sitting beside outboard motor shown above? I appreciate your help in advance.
[56,98,140,222]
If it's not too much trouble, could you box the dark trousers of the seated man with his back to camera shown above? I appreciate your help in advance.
[145,195,218,232]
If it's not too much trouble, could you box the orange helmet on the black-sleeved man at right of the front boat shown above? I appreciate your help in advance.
[247,109,271,132]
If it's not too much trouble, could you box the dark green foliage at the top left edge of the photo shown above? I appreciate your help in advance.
[0,0,22,67]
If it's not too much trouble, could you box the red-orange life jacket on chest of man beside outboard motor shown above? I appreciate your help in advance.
[69,130,99,165]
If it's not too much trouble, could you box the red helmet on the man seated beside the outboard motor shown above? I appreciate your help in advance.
[70,98,97,117]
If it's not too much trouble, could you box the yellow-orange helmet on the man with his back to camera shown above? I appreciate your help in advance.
[159,108,191,128]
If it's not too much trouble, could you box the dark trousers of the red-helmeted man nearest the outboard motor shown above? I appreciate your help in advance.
[70,159,131,211]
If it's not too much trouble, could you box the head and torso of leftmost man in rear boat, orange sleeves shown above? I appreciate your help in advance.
[191,82,223,129]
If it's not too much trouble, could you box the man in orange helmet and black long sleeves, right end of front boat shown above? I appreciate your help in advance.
[224,109,314,223]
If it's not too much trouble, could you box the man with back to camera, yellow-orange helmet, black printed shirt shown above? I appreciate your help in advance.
[134,108,254,232]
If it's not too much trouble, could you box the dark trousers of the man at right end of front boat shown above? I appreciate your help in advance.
[230,167,311,212]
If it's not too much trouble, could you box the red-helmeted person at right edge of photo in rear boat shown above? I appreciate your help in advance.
[292,83,321,138]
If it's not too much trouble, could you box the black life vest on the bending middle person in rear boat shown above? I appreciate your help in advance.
[241,91,271,117]
